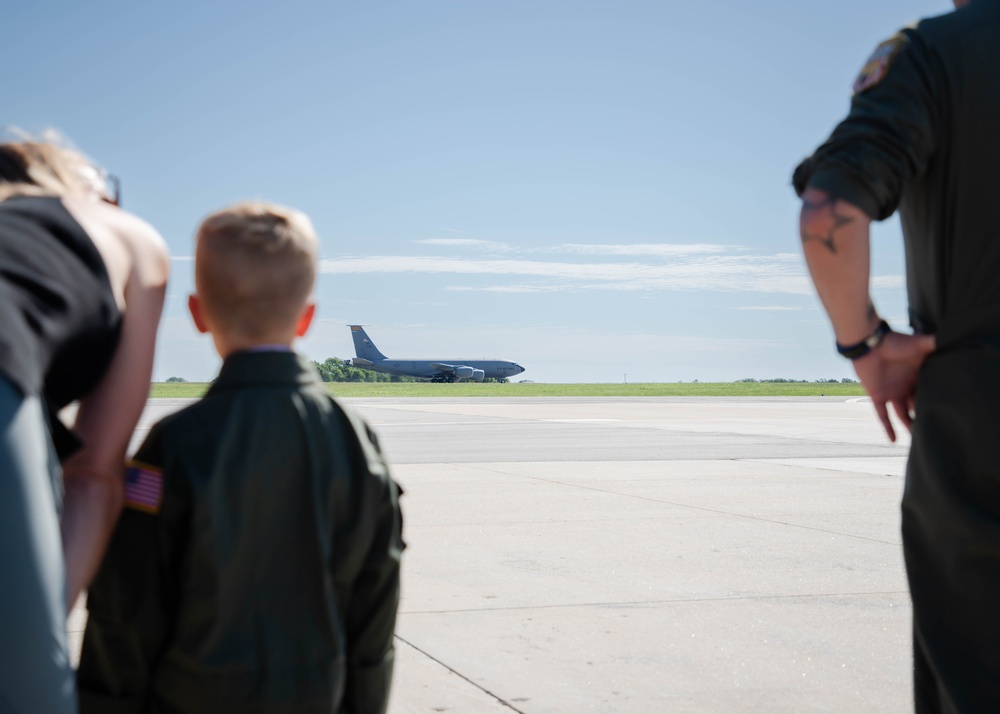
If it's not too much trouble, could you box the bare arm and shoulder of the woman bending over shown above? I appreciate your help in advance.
[62,202,170,608]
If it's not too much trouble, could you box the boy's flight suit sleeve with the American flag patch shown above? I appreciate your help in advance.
[77,427,184,714]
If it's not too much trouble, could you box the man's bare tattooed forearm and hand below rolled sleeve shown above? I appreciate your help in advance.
[799,188,934,441]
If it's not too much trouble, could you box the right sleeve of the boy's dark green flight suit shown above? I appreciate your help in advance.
[340,415,405,714]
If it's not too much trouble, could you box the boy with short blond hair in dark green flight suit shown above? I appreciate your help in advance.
[78,203,403,714]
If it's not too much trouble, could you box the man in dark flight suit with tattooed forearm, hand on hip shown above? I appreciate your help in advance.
[793,0,1000,712]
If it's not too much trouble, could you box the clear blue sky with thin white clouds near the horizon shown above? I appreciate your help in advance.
[0,0,951,382]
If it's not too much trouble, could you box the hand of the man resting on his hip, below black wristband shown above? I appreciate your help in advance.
[854,332,936,441]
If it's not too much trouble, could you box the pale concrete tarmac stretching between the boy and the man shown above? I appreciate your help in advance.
[71,397,912,714]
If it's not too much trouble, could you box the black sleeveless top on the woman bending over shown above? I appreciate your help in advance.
[0,196,122,455]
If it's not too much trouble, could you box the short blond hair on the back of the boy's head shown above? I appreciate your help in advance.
[195,201,319,340]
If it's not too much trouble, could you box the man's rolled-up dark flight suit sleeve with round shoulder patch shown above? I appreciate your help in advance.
[792,30,942,220]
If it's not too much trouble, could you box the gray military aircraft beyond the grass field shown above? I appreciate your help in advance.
[350,325,524,382]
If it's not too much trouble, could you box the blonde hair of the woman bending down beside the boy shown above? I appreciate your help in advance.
[0,134,101,201]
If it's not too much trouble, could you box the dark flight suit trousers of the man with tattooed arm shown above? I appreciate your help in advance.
[902,347,1000,714]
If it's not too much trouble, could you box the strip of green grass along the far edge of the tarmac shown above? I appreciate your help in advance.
[150,382,864,399]
